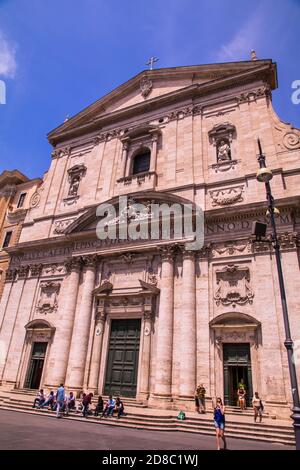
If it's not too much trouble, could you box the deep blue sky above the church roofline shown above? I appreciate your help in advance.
[0,0,300,178]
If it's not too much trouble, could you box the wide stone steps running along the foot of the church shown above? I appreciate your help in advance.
[0,397,294,445]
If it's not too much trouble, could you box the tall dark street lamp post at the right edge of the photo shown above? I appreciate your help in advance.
[256,139,300,450]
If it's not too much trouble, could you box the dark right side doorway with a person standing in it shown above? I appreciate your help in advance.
[223,343,253,406]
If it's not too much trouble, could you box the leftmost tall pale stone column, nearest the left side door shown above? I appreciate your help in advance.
[45,258,82,388]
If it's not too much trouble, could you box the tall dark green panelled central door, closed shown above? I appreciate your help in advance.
[104,319,141,397]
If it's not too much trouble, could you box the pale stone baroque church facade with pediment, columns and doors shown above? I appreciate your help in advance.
[0,60,300,416]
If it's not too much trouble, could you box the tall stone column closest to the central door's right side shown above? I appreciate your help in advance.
[154,251,174,401]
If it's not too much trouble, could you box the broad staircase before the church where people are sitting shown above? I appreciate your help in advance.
[0,390,295,445]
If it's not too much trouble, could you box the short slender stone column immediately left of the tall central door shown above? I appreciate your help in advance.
[88,308,106,393]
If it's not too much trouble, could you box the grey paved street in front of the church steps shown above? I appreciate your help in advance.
[0,410,293,450]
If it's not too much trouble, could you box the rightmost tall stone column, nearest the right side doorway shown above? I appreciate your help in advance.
[179,251,196,398]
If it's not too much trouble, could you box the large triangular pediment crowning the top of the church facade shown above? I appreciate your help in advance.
[48,60,276,142]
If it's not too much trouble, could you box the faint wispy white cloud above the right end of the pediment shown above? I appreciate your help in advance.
[216,8,264,61]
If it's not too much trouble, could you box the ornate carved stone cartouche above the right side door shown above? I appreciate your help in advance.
[214,264,254,307]
